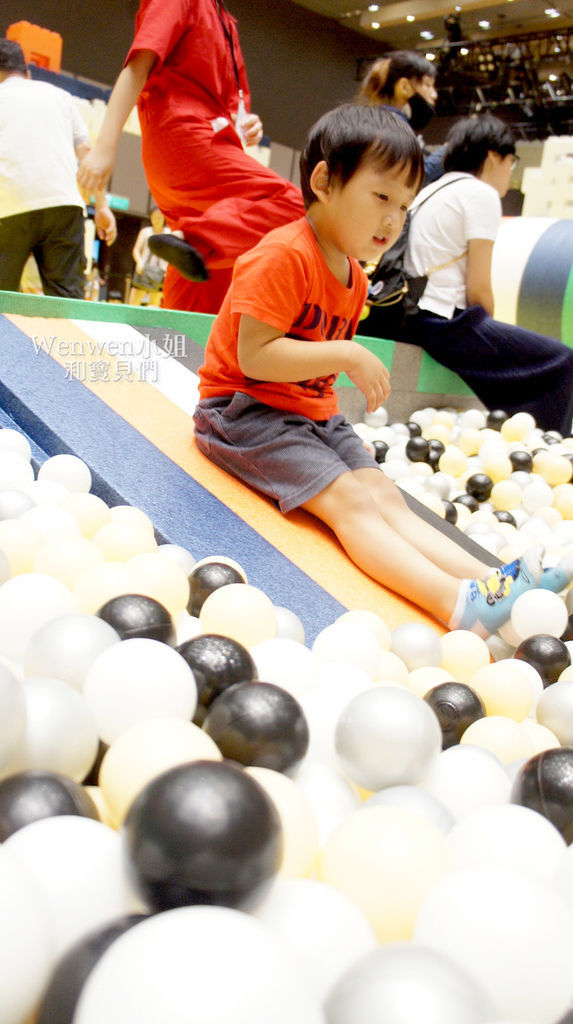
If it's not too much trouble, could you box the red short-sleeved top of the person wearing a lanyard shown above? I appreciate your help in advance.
[124,0,250,122]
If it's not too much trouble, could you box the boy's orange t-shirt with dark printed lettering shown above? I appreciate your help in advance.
[199,217,367,420]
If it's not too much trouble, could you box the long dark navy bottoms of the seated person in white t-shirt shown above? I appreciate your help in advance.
[361,305,573,436]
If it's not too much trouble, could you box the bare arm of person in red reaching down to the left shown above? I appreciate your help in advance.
[78,50,157,189]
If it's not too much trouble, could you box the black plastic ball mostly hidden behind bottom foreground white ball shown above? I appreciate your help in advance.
[34,913,147,1024]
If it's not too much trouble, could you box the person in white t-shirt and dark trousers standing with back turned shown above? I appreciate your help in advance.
[0,39,117,299]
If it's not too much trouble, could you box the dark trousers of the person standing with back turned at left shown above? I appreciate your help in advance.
[0,206,86,299]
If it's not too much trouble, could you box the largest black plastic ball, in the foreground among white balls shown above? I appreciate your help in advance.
[123,761,282,910]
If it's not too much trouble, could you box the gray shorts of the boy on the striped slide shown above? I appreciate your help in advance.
[193,391,379,512]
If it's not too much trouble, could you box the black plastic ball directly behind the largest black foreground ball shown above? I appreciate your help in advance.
[203,683,309,772]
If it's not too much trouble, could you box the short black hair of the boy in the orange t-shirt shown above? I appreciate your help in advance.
[300,103,424,209]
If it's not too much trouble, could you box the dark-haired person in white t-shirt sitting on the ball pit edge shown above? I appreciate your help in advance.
[400,114,573,435]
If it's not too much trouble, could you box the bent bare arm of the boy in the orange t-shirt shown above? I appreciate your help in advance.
[237,313,390,413]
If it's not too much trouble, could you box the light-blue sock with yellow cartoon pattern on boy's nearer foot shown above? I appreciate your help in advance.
[448,545,543,639]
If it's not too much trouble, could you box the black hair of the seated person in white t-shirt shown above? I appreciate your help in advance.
[443,114,516,174]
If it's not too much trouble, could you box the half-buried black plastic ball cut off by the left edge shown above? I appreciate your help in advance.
[0,769,99,843]
